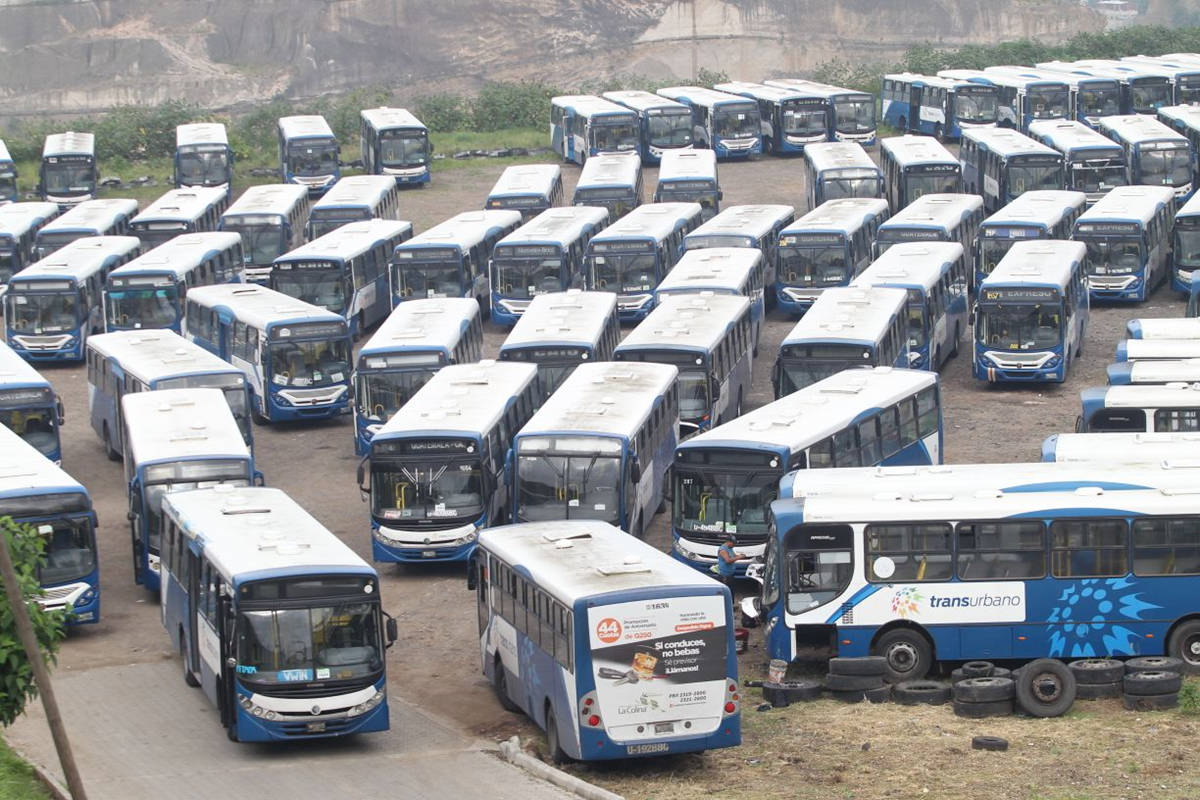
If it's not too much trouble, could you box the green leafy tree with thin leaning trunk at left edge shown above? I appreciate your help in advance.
[0,517,66,727]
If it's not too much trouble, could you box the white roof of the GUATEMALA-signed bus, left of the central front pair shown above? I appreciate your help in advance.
[371,361,538,444]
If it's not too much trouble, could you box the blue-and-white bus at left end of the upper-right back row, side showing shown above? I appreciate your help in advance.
[881,72,1000,140]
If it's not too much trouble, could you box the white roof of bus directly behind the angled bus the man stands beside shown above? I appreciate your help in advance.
[782,287,908,345]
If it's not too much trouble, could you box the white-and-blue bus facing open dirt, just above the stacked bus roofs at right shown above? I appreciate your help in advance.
[972,241,1091,384]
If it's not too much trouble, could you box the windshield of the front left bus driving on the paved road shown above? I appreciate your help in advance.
[238,602,383,686]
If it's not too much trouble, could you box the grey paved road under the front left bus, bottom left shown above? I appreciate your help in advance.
[5,661,568,800]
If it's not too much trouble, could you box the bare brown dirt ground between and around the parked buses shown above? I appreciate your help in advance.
[43,151,1200,799]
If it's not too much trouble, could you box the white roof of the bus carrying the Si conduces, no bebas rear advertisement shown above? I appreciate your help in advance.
[479,519,722,606]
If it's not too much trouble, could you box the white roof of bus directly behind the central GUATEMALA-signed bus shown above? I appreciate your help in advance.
[500,287,614,353]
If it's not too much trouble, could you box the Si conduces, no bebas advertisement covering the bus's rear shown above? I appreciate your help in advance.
[588,595,730,741]
